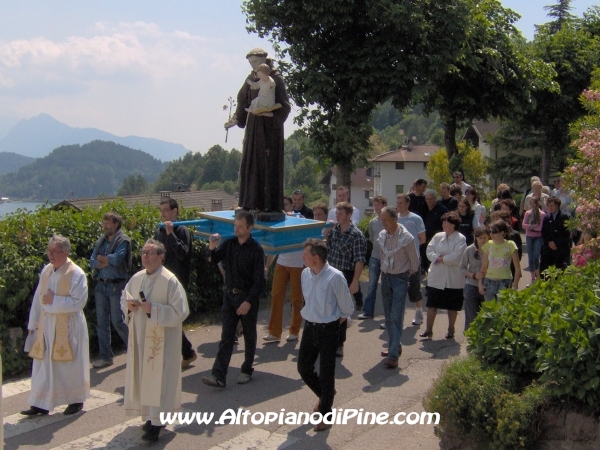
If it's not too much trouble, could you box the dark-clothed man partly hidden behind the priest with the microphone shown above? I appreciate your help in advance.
[154,198,198,369]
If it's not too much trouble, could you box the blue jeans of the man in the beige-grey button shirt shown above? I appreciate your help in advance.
[381,273,408,359]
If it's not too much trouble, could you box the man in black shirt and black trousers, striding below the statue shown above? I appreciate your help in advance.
[202,210,266,388]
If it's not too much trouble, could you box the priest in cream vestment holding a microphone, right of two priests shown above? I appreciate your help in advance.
[121,239,189,442]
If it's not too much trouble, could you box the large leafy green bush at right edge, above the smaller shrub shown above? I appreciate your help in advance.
[465,262,600,412]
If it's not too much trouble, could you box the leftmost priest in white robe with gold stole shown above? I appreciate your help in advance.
[21,234,90,416]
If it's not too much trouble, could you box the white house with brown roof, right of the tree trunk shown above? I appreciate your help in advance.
[370,145,440,206]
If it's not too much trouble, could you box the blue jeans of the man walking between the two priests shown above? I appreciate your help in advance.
[94,281,129,361]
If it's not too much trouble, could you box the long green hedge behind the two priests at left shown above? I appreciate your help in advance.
[0,200,223,376]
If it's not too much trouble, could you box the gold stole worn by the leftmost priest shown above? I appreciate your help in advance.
[29,259,75,362]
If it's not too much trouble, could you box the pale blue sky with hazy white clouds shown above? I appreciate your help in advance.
[0,0,594,153]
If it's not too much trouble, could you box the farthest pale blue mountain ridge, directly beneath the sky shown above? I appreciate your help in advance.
[0,114,189,161]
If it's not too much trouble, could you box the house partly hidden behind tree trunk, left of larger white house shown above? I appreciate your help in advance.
[321,167,373,219]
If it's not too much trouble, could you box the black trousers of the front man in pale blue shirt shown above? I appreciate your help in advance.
[298,320,340,414]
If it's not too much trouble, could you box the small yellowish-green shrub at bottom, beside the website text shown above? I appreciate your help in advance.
[423,356,548,450]
